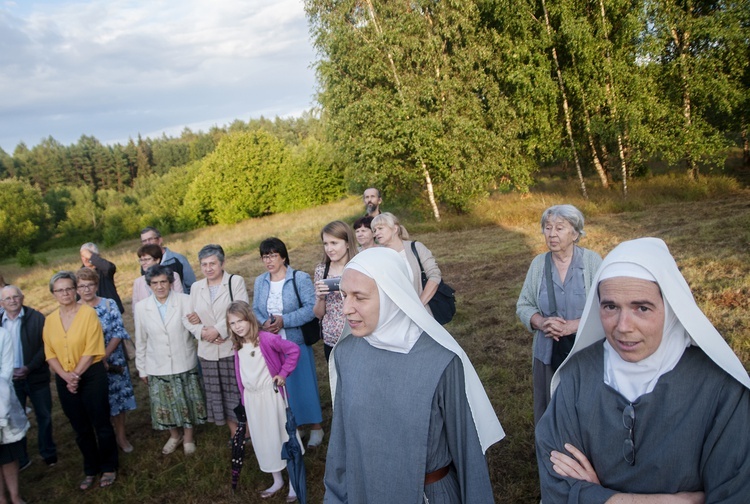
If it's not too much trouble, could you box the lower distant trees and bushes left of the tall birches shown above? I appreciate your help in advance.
[0,113,345,258]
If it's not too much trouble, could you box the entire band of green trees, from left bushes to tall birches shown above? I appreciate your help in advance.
[0,0,750,256]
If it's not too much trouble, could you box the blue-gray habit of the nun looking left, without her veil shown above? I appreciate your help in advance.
[324,333,494,504]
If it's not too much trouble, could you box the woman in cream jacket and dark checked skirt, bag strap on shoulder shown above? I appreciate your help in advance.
[184,244,250,436]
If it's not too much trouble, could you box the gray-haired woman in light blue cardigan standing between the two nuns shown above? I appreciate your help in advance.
[516,205,602,424]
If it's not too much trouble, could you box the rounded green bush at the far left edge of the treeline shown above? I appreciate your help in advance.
[0,179,50,257]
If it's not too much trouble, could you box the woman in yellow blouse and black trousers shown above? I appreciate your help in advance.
[43,271,118,490]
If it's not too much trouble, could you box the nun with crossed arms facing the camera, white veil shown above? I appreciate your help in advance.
[536,238,750,504]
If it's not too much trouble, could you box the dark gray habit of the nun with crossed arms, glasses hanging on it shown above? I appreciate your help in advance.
[536,343,750,504]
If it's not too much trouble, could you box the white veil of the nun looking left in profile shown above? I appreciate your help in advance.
[328,247,505,452]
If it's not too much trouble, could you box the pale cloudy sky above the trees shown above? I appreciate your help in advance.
[0,0,316,155]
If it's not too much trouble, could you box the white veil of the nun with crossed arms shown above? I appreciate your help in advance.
[552,238,750,397]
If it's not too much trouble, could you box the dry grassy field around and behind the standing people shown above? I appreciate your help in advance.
[7,172,750,504]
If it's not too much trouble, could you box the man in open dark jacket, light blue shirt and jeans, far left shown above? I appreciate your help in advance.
[0,285,57,470]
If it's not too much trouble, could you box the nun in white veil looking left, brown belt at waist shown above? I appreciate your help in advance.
[324,248,505,504]
